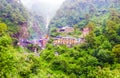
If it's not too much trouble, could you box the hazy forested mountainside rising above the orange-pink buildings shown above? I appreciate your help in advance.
[50,0,120,28]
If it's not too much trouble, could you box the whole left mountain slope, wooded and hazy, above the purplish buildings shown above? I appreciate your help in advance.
[0,0,45,38]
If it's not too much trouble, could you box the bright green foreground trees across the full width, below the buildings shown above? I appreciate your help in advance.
[0,9,120,78]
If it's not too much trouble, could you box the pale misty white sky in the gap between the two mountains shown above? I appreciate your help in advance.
[21,0,65,16]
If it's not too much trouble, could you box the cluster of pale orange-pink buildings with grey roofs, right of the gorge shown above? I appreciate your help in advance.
[53,27,90,45]
